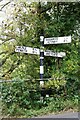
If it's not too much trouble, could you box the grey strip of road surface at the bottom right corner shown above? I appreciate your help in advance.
[37,112,80,120]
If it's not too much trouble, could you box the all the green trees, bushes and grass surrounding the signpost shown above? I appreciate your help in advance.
[0,1,80,116]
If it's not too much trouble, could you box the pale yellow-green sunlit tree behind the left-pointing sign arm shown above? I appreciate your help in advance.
[1,2,38,79]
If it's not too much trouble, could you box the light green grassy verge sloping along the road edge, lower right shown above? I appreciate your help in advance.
[22,98,78,118]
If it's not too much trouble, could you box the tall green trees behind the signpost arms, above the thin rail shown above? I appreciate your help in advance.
[0,1,80,79]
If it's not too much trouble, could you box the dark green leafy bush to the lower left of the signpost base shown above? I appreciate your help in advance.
[1,79,41,115]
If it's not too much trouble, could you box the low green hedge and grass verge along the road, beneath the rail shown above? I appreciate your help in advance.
[1,76,79,117]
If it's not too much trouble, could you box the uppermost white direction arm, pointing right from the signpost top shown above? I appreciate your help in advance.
[44,36,71,45]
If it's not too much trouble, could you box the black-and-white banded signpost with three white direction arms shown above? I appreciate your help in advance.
[15,36,71,85]
